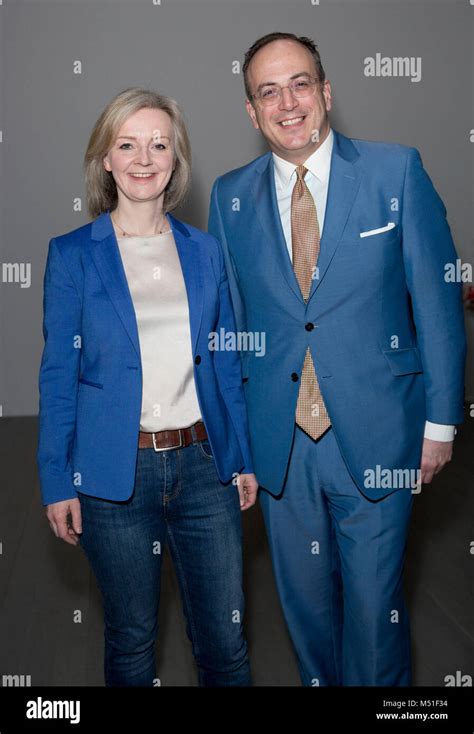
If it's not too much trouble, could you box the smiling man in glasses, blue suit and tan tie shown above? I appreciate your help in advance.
[209,33,465,686]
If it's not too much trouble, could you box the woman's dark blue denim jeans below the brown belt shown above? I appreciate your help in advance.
[78,440,251,686]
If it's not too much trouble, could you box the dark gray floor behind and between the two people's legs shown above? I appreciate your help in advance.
[0,417,474,686]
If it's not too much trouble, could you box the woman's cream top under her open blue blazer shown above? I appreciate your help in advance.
[117,232,201,432]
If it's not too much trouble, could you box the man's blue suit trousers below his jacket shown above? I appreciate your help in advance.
[259,426,413,686]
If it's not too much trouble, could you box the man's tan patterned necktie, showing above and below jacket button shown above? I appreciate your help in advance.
[291,165,331,439]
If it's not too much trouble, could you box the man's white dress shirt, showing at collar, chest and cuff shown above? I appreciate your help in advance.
[272,129,456,441]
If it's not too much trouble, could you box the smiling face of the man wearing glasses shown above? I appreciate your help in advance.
[246,40,331,165]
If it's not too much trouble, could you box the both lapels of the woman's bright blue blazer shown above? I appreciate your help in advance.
[91,210,202,357]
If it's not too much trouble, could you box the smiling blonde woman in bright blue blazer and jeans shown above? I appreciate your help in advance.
[37,88,258,686]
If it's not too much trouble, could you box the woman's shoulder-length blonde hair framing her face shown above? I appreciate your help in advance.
[84,87,191,219]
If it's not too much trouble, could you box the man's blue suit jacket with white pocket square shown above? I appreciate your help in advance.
[209,131,466,499]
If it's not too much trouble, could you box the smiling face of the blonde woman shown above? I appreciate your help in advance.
[104,108,175,206]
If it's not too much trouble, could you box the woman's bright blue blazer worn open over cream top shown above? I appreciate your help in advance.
[37,212,253,505]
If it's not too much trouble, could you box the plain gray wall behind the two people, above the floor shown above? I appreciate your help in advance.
[0,0,474,416]
